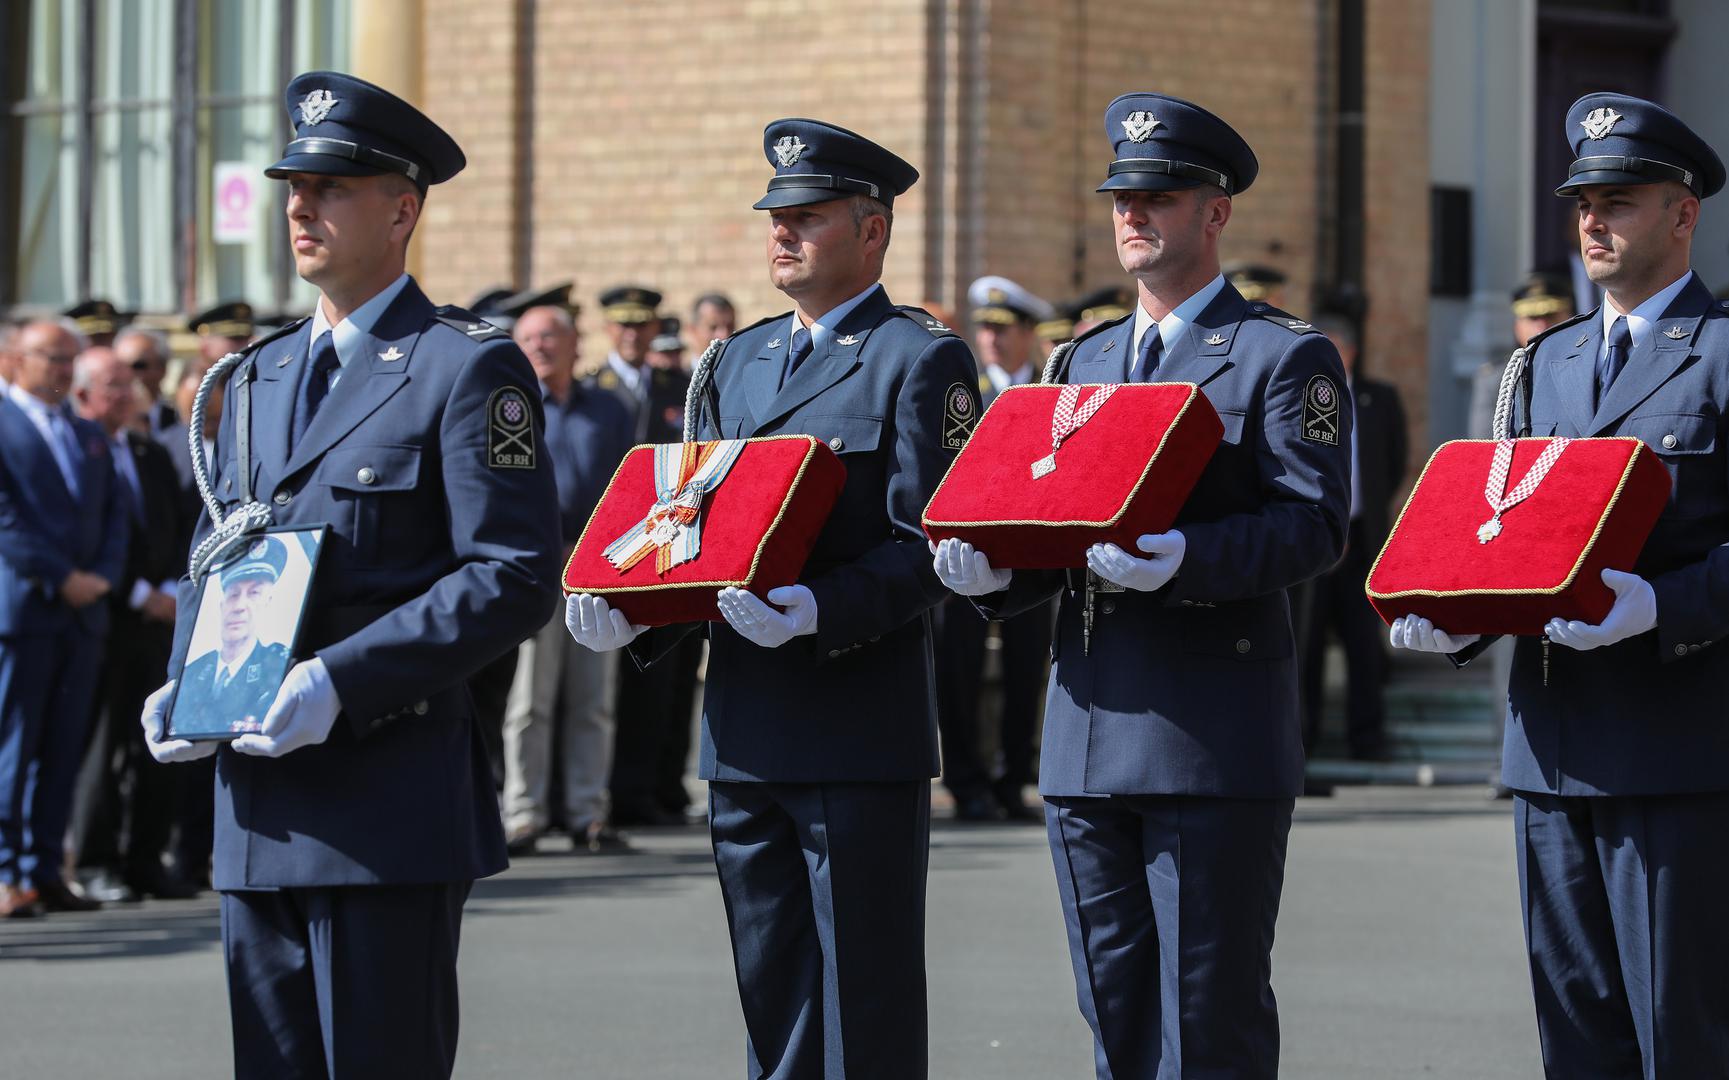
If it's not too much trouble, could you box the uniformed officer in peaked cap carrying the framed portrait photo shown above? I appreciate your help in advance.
[144,71,558,1077]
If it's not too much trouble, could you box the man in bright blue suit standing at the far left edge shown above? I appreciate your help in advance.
[0,321,126,916]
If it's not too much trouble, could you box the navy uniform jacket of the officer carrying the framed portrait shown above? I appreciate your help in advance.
[171,283,558,890]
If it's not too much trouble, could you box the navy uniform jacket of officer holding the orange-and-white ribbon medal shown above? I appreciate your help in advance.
[633,287,979,783]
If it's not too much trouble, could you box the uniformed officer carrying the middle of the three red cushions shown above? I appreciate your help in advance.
[937,93,1350,1080]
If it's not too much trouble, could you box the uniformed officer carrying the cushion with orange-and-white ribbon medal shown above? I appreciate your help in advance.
[565,119,979,1080]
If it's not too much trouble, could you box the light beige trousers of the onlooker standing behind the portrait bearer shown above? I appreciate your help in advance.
[505,607,619,836]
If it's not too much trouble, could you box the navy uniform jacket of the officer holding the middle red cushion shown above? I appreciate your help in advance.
[979,283,1352,798]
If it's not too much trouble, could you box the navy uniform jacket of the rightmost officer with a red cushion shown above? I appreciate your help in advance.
[1501,269,1729,795]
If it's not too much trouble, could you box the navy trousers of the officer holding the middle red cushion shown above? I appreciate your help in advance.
[1044,795,1295,1080]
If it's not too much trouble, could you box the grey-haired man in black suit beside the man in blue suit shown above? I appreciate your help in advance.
[73,347,194,900]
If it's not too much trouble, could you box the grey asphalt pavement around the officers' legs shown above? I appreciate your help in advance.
[0,786,1542,1080]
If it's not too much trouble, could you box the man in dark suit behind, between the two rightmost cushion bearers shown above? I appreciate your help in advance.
[1302,313,1411,762]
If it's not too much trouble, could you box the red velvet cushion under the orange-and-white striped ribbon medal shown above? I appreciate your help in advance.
[564,435,847,626]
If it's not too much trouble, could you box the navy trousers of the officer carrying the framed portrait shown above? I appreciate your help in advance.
[221,881,472,1080]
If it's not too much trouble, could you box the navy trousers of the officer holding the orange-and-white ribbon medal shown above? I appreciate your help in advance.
[709,781,930,1080]
